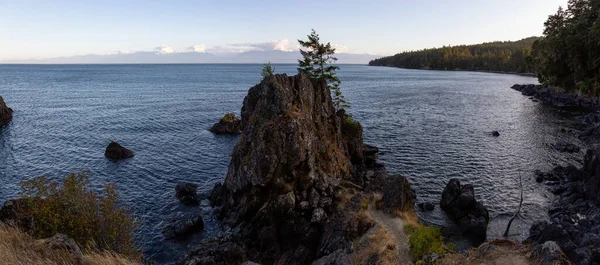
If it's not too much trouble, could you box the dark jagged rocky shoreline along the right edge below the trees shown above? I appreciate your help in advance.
[512,85,600,265]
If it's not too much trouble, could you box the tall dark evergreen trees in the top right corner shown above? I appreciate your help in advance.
[529,0,600,96]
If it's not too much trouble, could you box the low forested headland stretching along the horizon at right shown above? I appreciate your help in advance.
[369,37,539,73]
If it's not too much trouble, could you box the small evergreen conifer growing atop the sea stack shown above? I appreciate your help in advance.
[298,29,350,110]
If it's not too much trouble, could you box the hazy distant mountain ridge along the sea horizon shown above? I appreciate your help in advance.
[0,50,378,64]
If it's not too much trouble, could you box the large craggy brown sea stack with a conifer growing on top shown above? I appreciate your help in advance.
[178,74,412,265]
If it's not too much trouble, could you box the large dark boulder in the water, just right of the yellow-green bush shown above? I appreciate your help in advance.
[440,179,490,243]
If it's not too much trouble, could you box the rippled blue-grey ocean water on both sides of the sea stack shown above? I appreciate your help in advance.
[0,64,581,264]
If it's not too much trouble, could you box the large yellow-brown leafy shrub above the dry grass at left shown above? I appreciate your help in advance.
[21,172,141,258]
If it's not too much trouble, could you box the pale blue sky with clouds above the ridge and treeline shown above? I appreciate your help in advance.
[0,0,567,61]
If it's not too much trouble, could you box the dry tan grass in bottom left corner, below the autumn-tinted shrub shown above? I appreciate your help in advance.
[0,224,142,265]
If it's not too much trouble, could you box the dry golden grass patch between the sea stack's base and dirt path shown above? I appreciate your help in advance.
[351,225,399,265]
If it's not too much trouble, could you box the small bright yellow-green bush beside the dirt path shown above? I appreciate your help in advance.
[405,225,446,260]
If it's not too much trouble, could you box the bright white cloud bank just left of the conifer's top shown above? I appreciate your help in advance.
[206,39,298,53]
